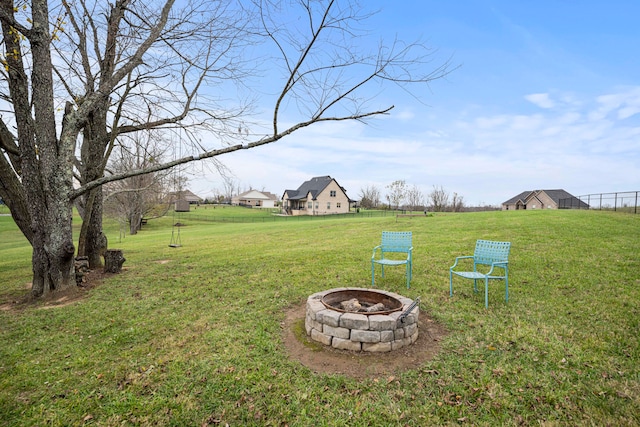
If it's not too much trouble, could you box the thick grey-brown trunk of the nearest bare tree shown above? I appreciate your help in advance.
[23,0,78,297]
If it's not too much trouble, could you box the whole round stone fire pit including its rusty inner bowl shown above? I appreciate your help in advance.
[305,288,419,352]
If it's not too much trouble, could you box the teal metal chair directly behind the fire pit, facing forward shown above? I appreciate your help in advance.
[371,231,413,289]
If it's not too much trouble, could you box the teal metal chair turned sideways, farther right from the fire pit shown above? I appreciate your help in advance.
[449,240,511,308]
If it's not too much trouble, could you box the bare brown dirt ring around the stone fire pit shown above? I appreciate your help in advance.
[282,302,447,378]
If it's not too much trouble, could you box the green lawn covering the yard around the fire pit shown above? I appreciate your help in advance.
[0,210,640,426]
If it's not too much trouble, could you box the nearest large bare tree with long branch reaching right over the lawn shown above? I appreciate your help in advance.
[0,0,450,296]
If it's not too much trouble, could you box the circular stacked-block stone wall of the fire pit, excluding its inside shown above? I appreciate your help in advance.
[305,288,420,352]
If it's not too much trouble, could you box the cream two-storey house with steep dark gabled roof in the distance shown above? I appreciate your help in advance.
[282,175,355,215]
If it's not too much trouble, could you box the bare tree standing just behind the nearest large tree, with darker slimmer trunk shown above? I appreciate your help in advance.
[64,0,251,267]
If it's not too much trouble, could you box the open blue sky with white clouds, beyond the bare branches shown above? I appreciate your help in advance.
[189,0,640,205]
